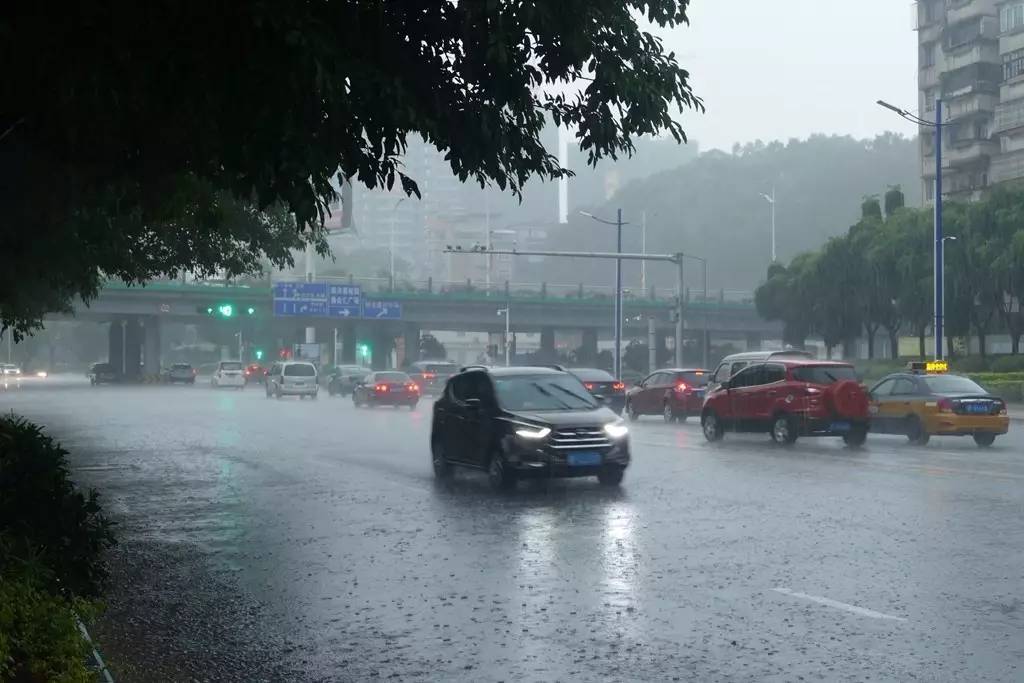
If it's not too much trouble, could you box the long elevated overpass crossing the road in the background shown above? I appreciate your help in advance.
[68,279,781,373]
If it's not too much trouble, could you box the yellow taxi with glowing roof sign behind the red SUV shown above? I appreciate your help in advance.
[868,360,1010,447]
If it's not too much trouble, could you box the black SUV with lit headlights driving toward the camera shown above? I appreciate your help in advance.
[430,367,630,490]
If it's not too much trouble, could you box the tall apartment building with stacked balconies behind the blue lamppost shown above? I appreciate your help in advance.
[914,0,1024,202]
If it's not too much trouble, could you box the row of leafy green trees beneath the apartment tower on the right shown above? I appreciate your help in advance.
[756,186,1024,357]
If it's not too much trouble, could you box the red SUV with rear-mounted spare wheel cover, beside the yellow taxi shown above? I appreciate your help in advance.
[700,359,868,445]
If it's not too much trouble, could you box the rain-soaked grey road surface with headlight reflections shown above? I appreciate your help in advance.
[0,378,1024,681]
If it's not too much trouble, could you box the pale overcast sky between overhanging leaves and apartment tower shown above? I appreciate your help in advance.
[658,0,918,150]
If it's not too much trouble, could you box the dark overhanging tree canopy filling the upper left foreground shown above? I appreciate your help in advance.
[0,0,702,331]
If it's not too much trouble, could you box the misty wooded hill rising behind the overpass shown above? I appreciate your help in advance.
[545,133,921,290]
